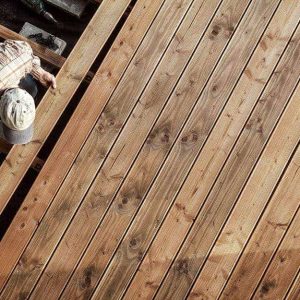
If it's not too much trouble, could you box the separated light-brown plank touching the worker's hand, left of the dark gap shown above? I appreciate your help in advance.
[0,0,130,216]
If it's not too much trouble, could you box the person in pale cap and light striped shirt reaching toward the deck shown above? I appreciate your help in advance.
[0,40,56,144]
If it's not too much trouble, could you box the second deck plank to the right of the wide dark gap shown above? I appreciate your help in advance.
[3,0,197,297]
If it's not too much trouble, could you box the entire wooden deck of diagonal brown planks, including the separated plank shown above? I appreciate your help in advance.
[0,0,300,300]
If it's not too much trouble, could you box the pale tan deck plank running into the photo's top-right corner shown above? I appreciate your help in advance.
[125,2,298,299]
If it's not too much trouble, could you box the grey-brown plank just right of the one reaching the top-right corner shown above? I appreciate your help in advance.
[157,19,300,299]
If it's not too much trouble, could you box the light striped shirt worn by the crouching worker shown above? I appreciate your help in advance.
[0,40,43,93]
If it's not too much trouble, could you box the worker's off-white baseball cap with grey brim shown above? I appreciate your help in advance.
[0,88,35,144]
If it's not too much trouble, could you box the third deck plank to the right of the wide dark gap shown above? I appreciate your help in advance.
[32,0,225,298]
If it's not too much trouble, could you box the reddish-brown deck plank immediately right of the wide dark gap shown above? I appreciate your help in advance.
[0,0,162,292]
